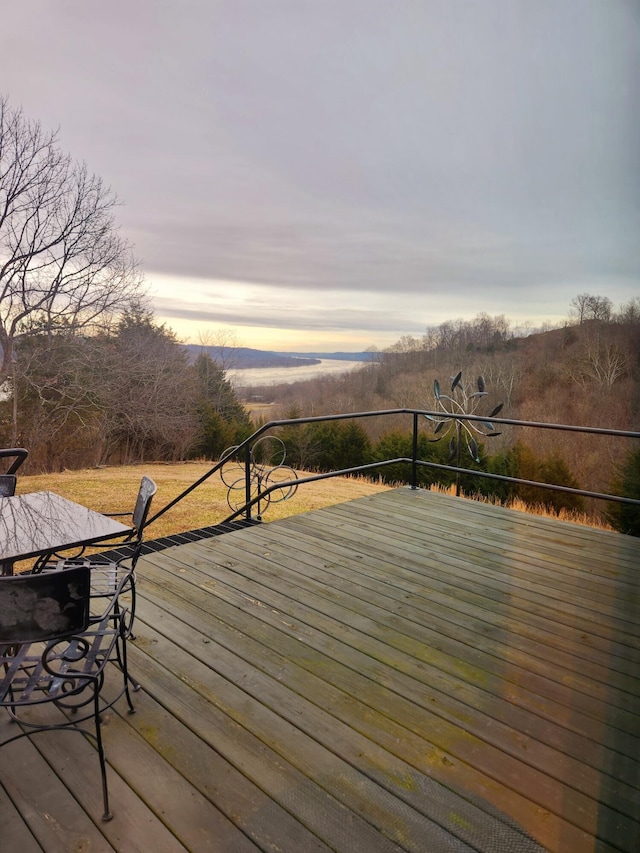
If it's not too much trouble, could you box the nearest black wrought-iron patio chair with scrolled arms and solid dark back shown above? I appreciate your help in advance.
[0,566,135,820]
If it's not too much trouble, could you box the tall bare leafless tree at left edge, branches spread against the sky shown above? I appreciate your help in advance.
[0,98,141,380]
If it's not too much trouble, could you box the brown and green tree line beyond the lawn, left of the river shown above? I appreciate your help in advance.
[0,304,252,471]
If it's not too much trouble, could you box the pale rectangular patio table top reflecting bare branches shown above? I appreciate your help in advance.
[0,492,131,573]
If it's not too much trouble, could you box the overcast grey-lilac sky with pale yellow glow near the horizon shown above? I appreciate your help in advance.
[0,0,640,351]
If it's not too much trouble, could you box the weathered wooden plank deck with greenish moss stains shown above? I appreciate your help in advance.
[0,488,640,853]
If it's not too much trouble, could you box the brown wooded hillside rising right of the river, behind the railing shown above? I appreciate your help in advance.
[242,318,640,506]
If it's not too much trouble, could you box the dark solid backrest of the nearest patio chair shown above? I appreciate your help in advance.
[0,566,91,644]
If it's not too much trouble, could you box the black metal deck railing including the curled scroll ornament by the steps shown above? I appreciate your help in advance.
[147,408,640,525]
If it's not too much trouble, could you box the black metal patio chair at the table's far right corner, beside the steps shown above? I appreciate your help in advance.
[41,476,157,635]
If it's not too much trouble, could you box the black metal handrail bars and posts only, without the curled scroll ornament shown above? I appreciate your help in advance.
[147,408,640,526]
